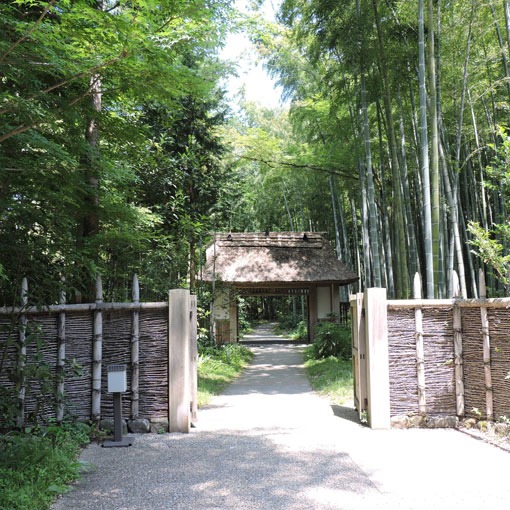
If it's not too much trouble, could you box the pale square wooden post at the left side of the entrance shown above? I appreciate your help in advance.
[168,289,191,433]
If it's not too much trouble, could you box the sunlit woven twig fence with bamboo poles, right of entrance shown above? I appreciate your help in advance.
[387,273,510,420]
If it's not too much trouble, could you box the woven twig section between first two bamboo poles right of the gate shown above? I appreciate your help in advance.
[423,307,457,416]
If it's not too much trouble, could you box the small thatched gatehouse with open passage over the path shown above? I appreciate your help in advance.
[202,231,358,343]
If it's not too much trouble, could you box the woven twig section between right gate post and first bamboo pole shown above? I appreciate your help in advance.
[388,309,419,416]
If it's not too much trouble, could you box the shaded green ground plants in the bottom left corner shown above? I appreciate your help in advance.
[0,424,90,510]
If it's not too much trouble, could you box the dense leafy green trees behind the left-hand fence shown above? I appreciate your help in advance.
[0,0,231,305]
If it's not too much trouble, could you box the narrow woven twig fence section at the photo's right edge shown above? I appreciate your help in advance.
[488,309,510,419]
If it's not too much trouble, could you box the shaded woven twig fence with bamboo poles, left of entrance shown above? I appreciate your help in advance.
[0,276,196,426]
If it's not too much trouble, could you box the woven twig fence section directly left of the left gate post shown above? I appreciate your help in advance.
[139,309,168,418]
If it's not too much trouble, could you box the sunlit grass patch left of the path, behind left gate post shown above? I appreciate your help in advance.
[198,344,253,407]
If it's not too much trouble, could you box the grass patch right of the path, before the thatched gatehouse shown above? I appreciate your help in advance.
[305,344,353,405]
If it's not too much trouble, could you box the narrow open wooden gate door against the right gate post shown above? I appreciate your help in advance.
[350,293,368,420]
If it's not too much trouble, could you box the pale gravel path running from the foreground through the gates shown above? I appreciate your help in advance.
[53,336,510,510]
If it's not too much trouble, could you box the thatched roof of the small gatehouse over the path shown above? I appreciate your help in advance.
[203,232,358,287]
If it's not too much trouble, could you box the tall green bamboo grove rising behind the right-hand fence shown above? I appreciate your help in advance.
[236,0,510,298]
